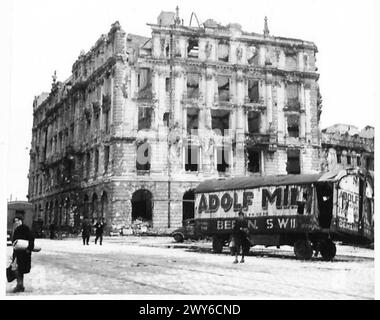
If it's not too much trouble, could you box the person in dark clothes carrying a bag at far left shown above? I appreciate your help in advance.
[12,217,34,293]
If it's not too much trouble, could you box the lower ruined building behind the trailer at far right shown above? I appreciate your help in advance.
[321,124,375,171]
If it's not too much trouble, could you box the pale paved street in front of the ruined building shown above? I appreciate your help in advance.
[6,236,375,299]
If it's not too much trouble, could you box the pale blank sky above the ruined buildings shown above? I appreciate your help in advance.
[0,0,379,200]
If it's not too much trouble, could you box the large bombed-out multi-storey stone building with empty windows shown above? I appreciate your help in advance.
[28,10,321,232]
